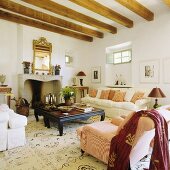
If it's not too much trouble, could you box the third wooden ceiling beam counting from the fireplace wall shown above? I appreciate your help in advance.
[22,0,117,34]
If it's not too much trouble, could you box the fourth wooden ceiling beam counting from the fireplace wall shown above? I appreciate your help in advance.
[69,0,133,28]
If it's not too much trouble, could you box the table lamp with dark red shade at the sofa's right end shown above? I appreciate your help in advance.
[148,87,166,109]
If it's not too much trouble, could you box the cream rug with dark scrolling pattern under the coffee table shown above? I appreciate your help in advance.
[0,115,149,170]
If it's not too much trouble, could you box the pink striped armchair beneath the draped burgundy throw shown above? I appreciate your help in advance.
[77,111,155,167]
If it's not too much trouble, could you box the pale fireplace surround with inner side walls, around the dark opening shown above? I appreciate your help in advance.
[18,74,62,102]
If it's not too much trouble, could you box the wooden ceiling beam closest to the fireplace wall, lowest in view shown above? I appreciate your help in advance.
[0,10,93,42]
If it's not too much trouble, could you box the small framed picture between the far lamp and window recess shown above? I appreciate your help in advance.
[91,66,101,83]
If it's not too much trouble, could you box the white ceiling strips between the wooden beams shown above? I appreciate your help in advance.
[12,0,170,30]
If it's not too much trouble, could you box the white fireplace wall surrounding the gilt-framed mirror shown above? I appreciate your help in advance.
[0,20,88,105]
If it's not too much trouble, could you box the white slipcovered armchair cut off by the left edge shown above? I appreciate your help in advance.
[0,104,27,151]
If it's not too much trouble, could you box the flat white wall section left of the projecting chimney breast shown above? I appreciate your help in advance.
[0,20,18,103]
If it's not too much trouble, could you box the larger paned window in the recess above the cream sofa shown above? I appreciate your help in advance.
[113,49,132,64]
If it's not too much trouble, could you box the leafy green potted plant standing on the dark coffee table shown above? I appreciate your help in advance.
[61,86,75,106]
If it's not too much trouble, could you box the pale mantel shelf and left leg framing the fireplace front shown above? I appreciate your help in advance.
[18,74,62,97]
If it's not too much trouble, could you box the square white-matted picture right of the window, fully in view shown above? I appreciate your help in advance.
[140,60,159,83]
